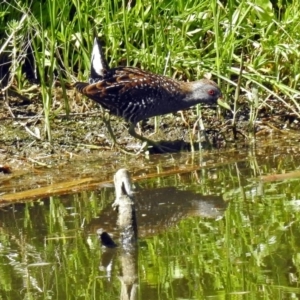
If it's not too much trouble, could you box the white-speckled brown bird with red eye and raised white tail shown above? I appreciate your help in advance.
[75,37,222,152]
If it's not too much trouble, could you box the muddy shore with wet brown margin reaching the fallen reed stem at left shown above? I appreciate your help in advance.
[0,90,300,199]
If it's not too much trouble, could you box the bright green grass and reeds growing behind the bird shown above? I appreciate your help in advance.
[0,0,300,140]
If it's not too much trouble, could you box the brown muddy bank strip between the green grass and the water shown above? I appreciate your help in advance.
[0,87,300,197]
